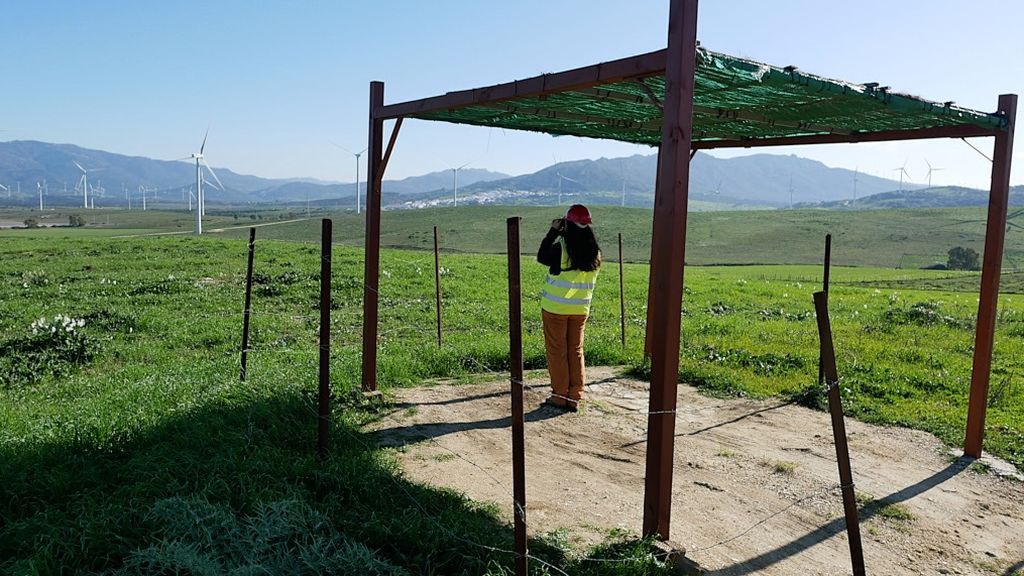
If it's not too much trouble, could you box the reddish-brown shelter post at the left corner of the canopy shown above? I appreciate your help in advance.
[362,82,384,390]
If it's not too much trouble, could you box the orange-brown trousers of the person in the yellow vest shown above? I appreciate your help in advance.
[541,310,587,407]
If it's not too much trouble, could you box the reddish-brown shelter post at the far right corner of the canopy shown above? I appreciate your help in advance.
[964,94,1017,458]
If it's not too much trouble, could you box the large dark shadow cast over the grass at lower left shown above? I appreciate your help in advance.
[0,390,573,574]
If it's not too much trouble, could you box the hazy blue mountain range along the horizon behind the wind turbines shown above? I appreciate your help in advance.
[0,140,1020,210]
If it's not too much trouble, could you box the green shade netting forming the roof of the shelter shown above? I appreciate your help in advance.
[411,48,1006,146]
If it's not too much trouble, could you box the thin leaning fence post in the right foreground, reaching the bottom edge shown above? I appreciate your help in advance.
[814,292,865,576]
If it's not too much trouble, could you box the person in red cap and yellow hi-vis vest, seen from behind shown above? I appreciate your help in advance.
[537,204,601,412]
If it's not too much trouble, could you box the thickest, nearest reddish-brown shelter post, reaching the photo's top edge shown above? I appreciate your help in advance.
[643,0,697,540]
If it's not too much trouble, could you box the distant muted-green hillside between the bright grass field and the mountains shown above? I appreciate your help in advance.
[8,206,1024,271]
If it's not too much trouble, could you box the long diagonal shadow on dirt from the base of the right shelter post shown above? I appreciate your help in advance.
[709,456,970,576]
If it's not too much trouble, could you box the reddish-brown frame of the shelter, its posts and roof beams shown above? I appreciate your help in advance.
[361,0,1017,539]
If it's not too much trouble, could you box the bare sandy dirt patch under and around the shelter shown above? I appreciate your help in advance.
[371,368,1024,576]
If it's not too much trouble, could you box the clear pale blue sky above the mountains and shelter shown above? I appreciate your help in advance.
[0,0,1024,187]
